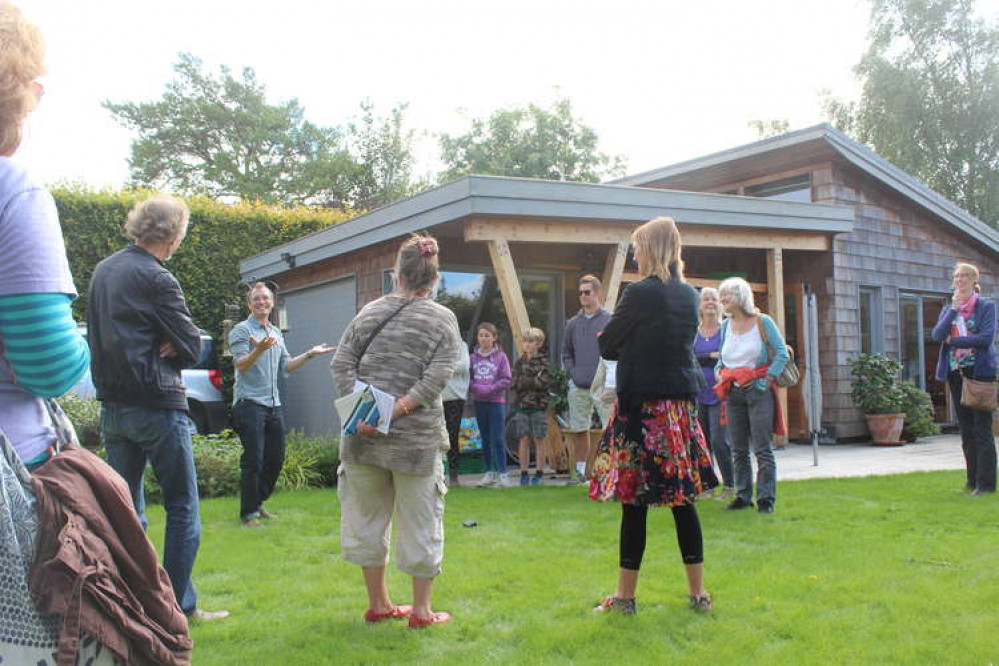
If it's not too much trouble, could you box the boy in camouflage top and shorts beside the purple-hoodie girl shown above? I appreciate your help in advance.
[511,328,549,486]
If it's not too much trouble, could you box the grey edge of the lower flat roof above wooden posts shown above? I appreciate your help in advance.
[240,176,854,279]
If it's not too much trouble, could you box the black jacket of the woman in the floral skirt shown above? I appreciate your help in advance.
[600,276,704,403]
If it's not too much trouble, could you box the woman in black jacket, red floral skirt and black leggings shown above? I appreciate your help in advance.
[590,217,718,614]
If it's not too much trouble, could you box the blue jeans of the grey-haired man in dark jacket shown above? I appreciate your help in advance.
[101,402,201,613]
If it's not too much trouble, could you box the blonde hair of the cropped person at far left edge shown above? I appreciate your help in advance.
[0,0,45,155]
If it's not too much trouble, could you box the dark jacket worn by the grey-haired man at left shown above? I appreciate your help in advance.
[87,245,201,410]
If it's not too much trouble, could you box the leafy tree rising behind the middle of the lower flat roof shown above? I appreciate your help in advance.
[439,98,624,182]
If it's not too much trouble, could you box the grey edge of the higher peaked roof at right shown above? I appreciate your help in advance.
[611,123,999,253]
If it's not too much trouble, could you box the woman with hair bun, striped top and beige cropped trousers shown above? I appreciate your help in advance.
[331,235,462,628]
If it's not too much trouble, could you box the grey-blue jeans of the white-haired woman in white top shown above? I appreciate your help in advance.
[725,384,777,502]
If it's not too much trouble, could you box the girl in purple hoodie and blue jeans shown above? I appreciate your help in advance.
[468,322,510,488]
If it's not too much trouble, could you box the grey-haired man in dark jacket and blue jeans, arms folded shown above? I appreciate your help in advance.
[87,195,228,620]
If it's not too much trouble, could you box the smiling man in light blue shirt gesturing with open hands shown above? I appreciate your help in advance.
[229,282,336,527]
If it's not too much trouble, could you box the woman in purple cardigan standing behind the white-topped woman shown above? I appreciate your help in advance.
[694,287,735,502]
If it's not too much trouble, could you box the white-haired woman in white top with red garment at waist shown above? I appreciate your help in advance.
[715,278,790,513]
